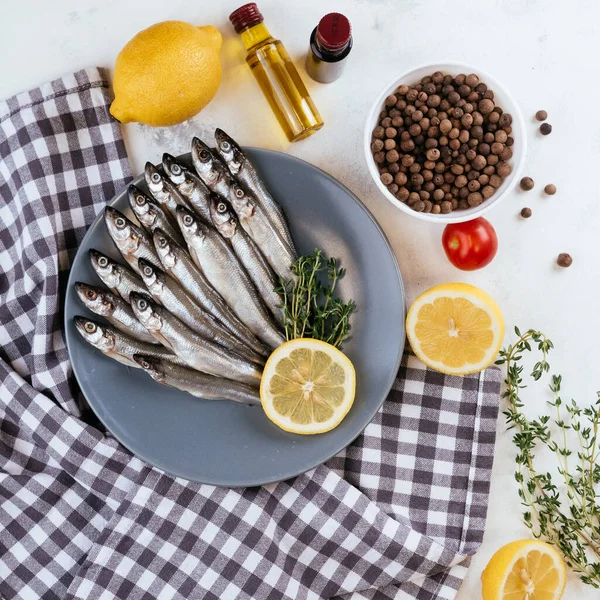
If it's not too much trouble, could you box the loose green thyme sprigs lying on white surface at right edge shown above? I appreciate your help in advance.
[496,328,600,588]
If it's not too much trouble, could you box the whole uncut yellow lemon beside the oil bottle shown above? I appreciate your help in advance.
[110,21,223,127]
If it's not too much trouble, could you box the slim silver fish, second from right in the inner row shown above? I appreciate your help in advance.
[210,194,283,325]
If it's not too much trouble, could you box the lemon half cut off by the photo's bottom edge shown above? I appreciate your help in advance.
[481,540,567,600]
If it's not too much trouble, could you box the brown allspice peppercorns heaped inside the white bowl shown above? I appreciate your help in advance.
[371,71,514,214]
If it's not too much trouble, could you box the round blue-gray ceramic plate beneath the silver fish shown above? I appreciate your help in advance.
[65,149,404,487]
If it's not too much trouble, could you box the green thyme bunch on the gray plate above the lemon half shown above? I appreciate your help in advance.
[276,248,356,348]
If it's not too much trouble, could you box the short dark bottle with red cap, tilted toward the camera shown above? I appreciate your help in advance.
[306,13,352,83]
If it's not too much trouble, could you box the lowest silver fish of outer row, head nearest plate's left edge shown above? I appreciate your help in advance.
[73,316,187,368]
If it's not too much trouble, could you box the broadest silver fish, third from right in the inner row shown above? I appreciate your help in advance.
[177,206,285,348]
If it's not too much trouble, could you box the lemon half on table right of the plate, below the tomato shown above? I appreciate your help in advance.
[406,283,504,375]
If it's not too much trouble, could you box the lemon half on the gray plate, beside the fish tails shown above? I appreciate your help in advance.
[260,338,356,435]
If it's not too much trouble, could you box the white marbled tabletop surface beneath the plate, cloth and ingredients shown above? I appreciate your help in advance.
[0,0,600,600]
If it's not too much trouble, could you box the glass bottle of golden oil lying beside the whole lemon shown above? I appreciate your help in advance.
[229,2,323,142]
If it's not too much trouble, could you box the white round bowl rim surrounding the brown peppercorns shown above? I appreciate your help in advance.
[364,63,527,223]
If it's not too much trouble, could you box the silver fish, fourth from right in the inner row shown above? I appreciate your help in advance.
[154,230,269,356]
